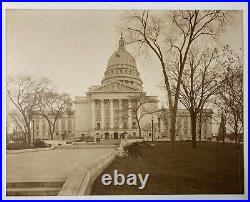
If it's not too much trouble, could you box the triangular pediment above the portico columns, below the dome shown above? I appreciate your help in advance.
[90,81,141,93]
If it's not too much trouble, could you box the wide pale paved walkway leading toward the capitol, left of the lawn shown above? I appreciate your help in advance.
[6,148,113,182]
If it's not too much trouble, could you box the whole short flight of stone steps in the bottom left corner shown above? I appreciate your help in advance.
[6,180,65,196]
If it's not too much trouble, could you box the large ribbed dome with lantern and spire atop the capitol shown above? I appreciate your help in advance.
[102,36,142,90]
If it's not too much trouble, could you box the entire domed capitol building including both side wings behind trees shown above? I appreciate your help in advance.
[9,36,212,140]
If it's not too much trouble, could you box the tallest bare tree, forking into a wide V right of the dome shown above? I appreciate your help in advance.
[125,10,229,151]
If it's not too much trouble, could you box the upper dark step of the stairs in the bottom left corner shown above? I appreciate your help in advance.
[6,181,64,189]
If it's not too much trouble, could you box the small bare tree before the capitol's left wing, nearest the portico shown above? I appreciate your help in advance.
[37,88,72,140]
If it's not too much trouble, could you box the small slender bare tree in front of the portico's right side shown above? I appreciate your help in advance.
[128,93,158,138]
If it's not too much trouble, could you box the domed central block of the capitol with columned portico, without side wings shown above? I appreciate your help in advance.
[74,36,158,139]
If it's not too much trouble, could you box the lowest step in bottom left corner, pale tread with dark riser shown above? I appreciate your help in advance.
[6,187,61,196]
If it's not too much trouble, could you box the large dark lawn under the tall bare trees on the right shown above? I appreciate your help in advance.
[91,142,243,195]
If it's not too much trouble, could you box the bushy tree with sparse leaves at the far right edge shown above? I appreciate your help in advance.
[215,46,244,143]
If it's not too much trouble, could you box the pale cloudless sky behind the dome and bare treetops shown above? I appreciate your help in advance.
[6,9,243,108]
